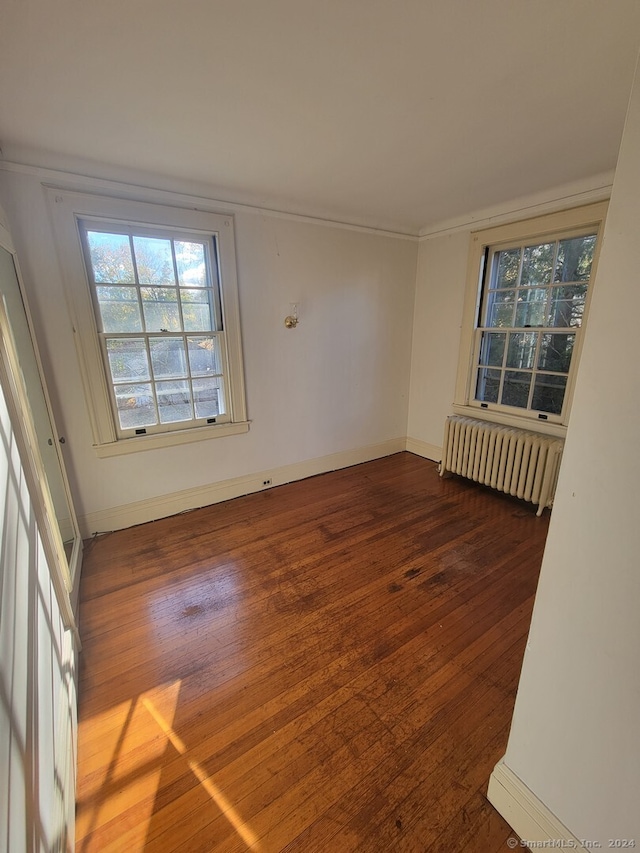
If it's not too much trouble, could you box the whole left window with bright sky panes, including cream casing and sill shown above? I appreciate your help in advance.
[51,191,248,455]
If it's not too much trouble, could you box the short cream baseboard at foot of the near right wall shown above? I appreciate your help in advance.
[487,758,582,849]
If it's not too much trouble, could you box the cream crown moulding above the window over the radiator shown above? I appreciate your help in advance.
[418,172,614,243]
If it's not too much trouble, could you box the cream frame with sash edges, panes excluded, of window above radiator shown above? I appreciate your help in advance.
[453,201,608,437]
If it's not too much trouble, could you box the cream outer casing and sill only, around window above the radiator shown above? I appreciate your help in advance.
[453,201,608,437]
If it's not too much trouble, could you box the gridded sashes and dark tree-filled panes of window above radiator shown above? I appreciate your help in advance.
[470,228,596,421]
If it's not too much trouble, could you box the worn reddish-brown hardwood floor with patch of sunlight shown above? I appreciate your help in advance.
[76,453,548,853]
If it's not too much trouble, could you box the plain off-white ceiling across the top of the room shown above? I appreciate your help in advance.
[0,0,640,233]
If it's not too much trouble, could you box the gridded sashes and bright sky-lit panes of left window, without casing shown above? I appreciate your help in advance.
[79,220,230,438]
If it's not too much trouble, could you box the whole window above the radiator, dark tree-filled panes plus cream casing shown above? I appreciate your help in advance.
[454,205,604,426]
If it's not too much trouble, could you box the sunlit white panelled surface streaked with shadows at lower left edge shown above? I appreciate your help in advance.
[0,376,76,853]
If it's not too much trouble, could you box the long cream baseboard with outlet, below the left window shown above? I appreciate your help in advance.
[78,437,406,539]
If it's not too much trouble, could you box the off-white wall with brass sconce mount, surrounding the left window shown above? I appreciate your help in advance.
[0,172,417,535]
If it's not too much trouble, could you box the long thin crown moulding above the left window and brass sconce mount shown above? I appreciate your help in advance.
[0,160,418,242]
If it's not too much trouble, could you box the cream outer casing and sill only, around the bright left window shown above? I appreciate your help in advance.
[45,187,249,457]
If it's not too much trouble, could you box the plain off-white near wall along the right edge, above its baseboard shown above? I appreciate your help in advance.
[494,61,640,849]
